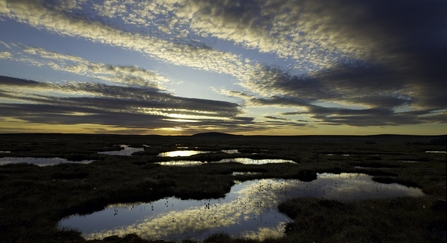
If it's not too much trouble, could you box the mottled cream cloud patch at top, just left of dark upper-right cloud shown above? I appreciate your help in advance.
[174,0,344,71]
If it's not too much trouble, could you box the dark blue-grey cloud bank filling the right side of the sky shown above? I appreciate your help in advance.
[226,0,447,126]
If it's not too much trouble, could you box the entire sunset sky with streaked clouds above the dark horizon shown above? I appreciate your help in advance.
[0,0,447,135]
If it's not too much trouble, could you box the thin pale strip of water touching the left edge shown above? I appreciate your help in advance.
[0,157,93,166]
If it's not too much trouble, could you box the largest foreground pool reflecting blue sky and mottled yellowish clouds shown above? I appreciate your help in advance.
[59,173,423,240]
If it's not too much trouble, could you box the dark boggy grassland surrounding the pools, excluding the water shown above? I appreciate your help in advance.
[0,134,446,242]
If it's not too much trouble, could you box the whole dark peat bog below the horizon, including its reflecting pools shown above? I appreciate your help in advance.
[0,134,446,242]
